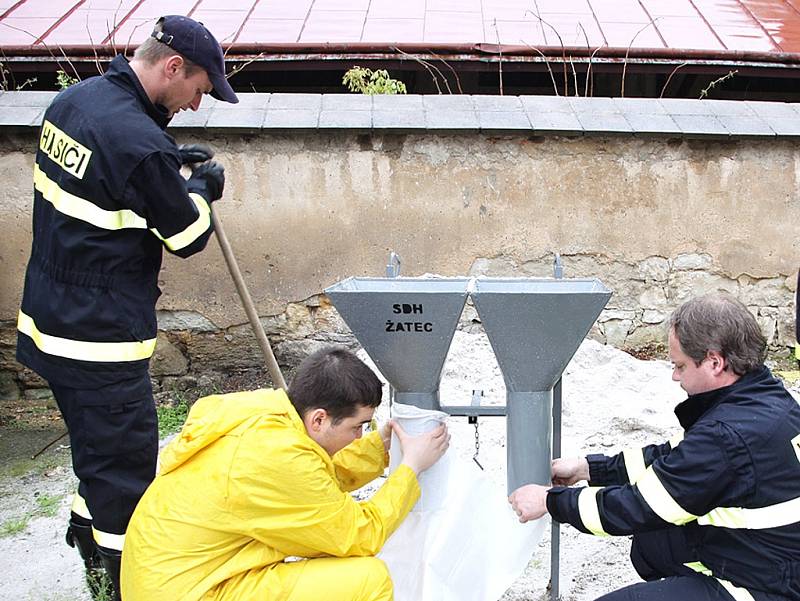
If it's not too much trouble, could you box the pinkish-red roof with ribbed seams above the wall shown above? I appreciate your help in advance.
[0,0,800,62]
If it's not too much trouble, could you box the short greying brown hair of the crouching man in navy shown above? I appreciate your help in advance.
[668,294,767,376]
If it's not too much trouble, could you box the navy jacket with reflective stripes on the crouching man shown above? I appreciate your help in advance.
[547,367,800,599]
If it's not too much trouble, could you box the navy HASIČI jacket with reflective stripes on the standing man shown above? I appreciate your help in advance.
[17,56,211,388]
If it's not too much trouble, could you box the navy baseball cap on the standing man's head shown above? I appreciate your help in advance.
[152,15,239,104]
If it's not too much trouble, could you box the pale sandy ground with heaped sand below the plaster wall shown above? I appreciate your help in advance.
[0,332,800,601]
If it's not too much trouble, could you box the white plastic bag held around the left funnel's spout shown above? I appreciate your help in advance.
[378,403,549,601]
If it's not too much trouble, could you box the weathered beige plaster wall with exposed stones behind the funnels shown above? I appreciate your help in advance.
[0,133,800,394]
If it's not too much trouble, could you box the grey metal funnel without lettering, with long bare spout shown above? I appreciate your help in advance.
[472,278,611,493]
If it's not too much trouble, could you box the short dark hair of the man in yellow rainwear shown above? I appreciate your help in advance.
[289,347,382,424]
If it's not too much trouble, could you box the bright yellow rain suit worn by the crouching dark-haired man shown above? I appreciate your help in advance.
[122,390,420,601]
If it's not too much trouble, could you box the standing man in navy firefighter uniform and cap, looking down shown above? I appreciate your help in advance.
[17,16,238,596]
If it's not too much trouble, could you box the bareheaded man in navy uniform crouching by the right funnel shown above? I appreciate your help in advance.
[509,295,800,601]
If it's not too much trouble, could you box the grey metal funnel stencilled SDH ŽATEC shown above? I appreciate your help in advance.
[325,278,469,409]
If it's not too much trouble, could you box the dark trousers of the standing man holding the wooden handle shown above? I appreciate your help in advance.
[50,375,158,550]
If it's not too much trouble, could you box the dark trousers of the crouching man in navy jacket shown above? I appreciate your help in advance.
[597,526,788,601]
